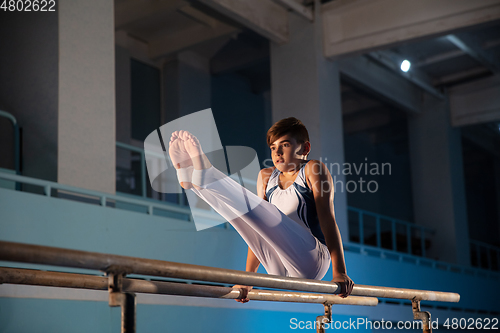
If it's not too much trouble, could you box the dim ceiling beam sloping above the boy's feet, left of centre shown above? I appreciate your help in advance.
[149,22,240,60]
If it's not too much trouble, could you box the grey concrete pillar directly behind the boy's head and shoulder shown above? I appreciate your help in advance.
[271,9,349,233]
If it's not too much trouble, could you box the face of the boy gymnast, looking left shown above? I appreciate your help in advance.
[269,134,309,172]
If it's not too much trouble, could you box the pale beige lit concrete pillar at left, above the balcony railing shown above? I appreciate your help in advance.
[57,0,116,193]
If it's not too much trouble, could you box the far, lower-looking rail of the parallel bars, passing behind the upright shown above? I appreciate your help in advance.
[0,267,378,306]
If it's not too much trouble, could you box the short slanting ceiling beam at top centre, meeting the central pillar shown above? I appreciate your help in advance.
[198,0,288,44]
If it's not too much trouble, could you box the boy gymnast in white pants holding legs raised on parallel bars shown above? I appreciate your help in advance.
[169,117,354,303]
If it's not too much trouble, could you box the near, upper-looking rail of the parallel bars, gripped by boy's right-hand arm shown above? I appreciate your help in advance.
[0,241,460,302]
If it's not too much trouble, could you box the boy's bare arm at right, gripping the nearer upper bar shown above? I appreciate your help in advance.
[306,161,354,297]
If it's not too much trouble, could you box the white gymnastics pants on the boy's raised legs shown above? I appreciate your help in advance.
[192,167,331,280]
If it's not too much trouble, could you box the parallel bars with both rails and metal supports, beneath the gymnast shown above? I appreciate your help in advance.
[0,241,460,333]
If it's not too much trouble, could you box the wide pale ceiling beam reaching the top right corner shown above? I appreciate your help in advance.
[322,0,500,59]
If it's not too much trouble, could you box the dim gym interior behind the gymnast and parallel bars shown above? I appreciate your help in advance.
[0,0,500,332]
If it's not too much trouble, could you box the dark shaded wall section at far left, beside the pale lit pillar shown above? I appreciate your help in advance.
[0,9,59,183]
